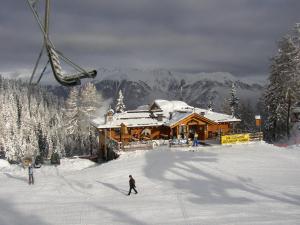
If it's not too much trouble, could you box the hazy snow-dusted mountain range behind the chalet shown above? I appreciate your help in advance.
[94,68,263,111]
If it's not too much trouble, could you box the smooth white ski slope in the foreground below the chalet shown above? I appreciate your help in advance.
[0,143,300,225]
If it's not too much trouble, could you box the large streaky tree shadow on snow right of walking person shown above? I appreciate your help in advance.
[144,151,300,205]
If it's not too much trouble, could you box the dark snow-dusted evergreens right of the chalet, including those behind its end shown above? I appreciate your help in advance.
[222,24,300,142]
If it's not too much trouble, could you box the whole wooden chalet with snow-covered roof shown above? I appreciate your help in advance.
[93,100,240,153]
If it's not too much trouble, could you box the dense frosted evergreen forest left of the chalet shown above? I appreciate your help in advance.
[0,76,100,162]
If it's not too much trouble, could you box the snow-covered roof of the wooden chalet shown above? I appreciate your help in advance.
[92,99,241,129]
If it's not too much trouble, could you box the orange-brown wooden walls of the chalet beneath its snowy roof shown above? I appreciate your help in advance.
[99,113,236,156]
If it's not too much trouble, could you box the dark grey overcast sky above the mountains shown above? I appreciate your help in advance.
[0,0,300,80]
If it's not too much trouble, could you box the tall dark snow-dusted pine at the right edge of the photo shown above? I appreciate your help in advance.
[265,35,300,141]
